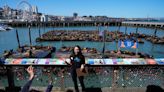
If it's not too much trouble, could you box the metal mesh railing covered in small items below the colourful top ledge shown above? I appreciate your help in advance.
[0,65,164,88]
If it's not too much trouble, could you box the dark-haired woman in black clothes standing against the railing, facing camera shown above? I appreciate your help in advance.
[66,45,85,92]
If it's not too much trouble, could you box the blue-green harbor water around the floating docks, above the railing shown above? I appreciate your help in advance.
[0,26,164,58]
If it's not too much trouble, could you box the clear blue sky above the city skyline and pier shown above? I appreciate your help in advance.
[0,0,164,18]
